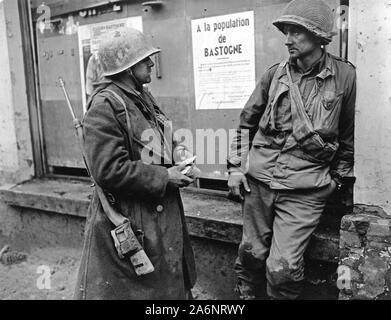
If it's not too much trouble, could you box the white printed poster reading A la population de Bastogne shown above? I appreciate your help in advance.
[192,11,256,110]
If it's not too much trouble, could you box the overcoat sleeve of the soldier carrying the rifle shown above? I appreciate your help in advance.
[83,97,168,198]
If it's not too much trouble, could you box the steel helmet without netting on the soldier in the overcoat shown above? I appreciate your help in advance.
[98,27,160,76]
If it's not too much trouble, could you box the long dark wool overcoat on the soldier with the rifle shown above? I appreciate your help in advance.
[75,73,196,300]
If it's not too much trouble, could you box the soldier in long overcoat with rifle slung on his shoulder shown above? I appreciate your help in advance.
[75,28,196,300]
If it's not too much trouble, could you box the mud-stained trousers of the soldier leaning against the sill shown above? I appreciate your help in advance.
[235,176,334,300]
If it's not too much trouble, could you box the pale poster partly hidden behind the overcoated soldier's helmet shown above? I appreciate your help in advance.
[78,16,143,112]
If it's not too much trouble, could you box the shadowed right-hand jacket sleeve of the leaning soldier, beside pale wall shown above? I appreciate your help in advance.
[331,69,356,185]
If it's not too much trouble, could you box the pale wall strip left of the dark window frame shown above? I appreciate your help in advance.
[0,0,34,184]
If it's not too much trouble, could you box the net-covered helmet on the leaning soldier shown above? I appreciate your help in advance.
[273,0,337,44]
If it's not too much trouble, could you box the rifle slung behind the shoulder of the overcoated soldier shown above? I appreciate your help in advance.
[59,77,155,276]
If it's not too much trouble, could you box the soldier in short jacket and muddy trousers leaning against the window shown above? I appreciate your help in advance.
[228,0,356,299]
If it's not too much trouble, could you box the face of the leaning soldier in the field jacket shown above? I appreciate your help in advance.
[284,25,321,60]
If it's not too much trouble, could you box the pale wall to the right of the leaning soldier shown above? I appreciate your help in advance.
[349,0,391,215]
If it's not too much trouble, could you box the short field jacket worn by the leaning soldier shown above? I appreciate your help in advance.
[228,53,356,190]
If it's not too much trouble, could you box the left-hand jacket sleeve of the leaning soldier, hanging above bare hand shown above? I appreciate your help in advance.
[227,65,278,172]
